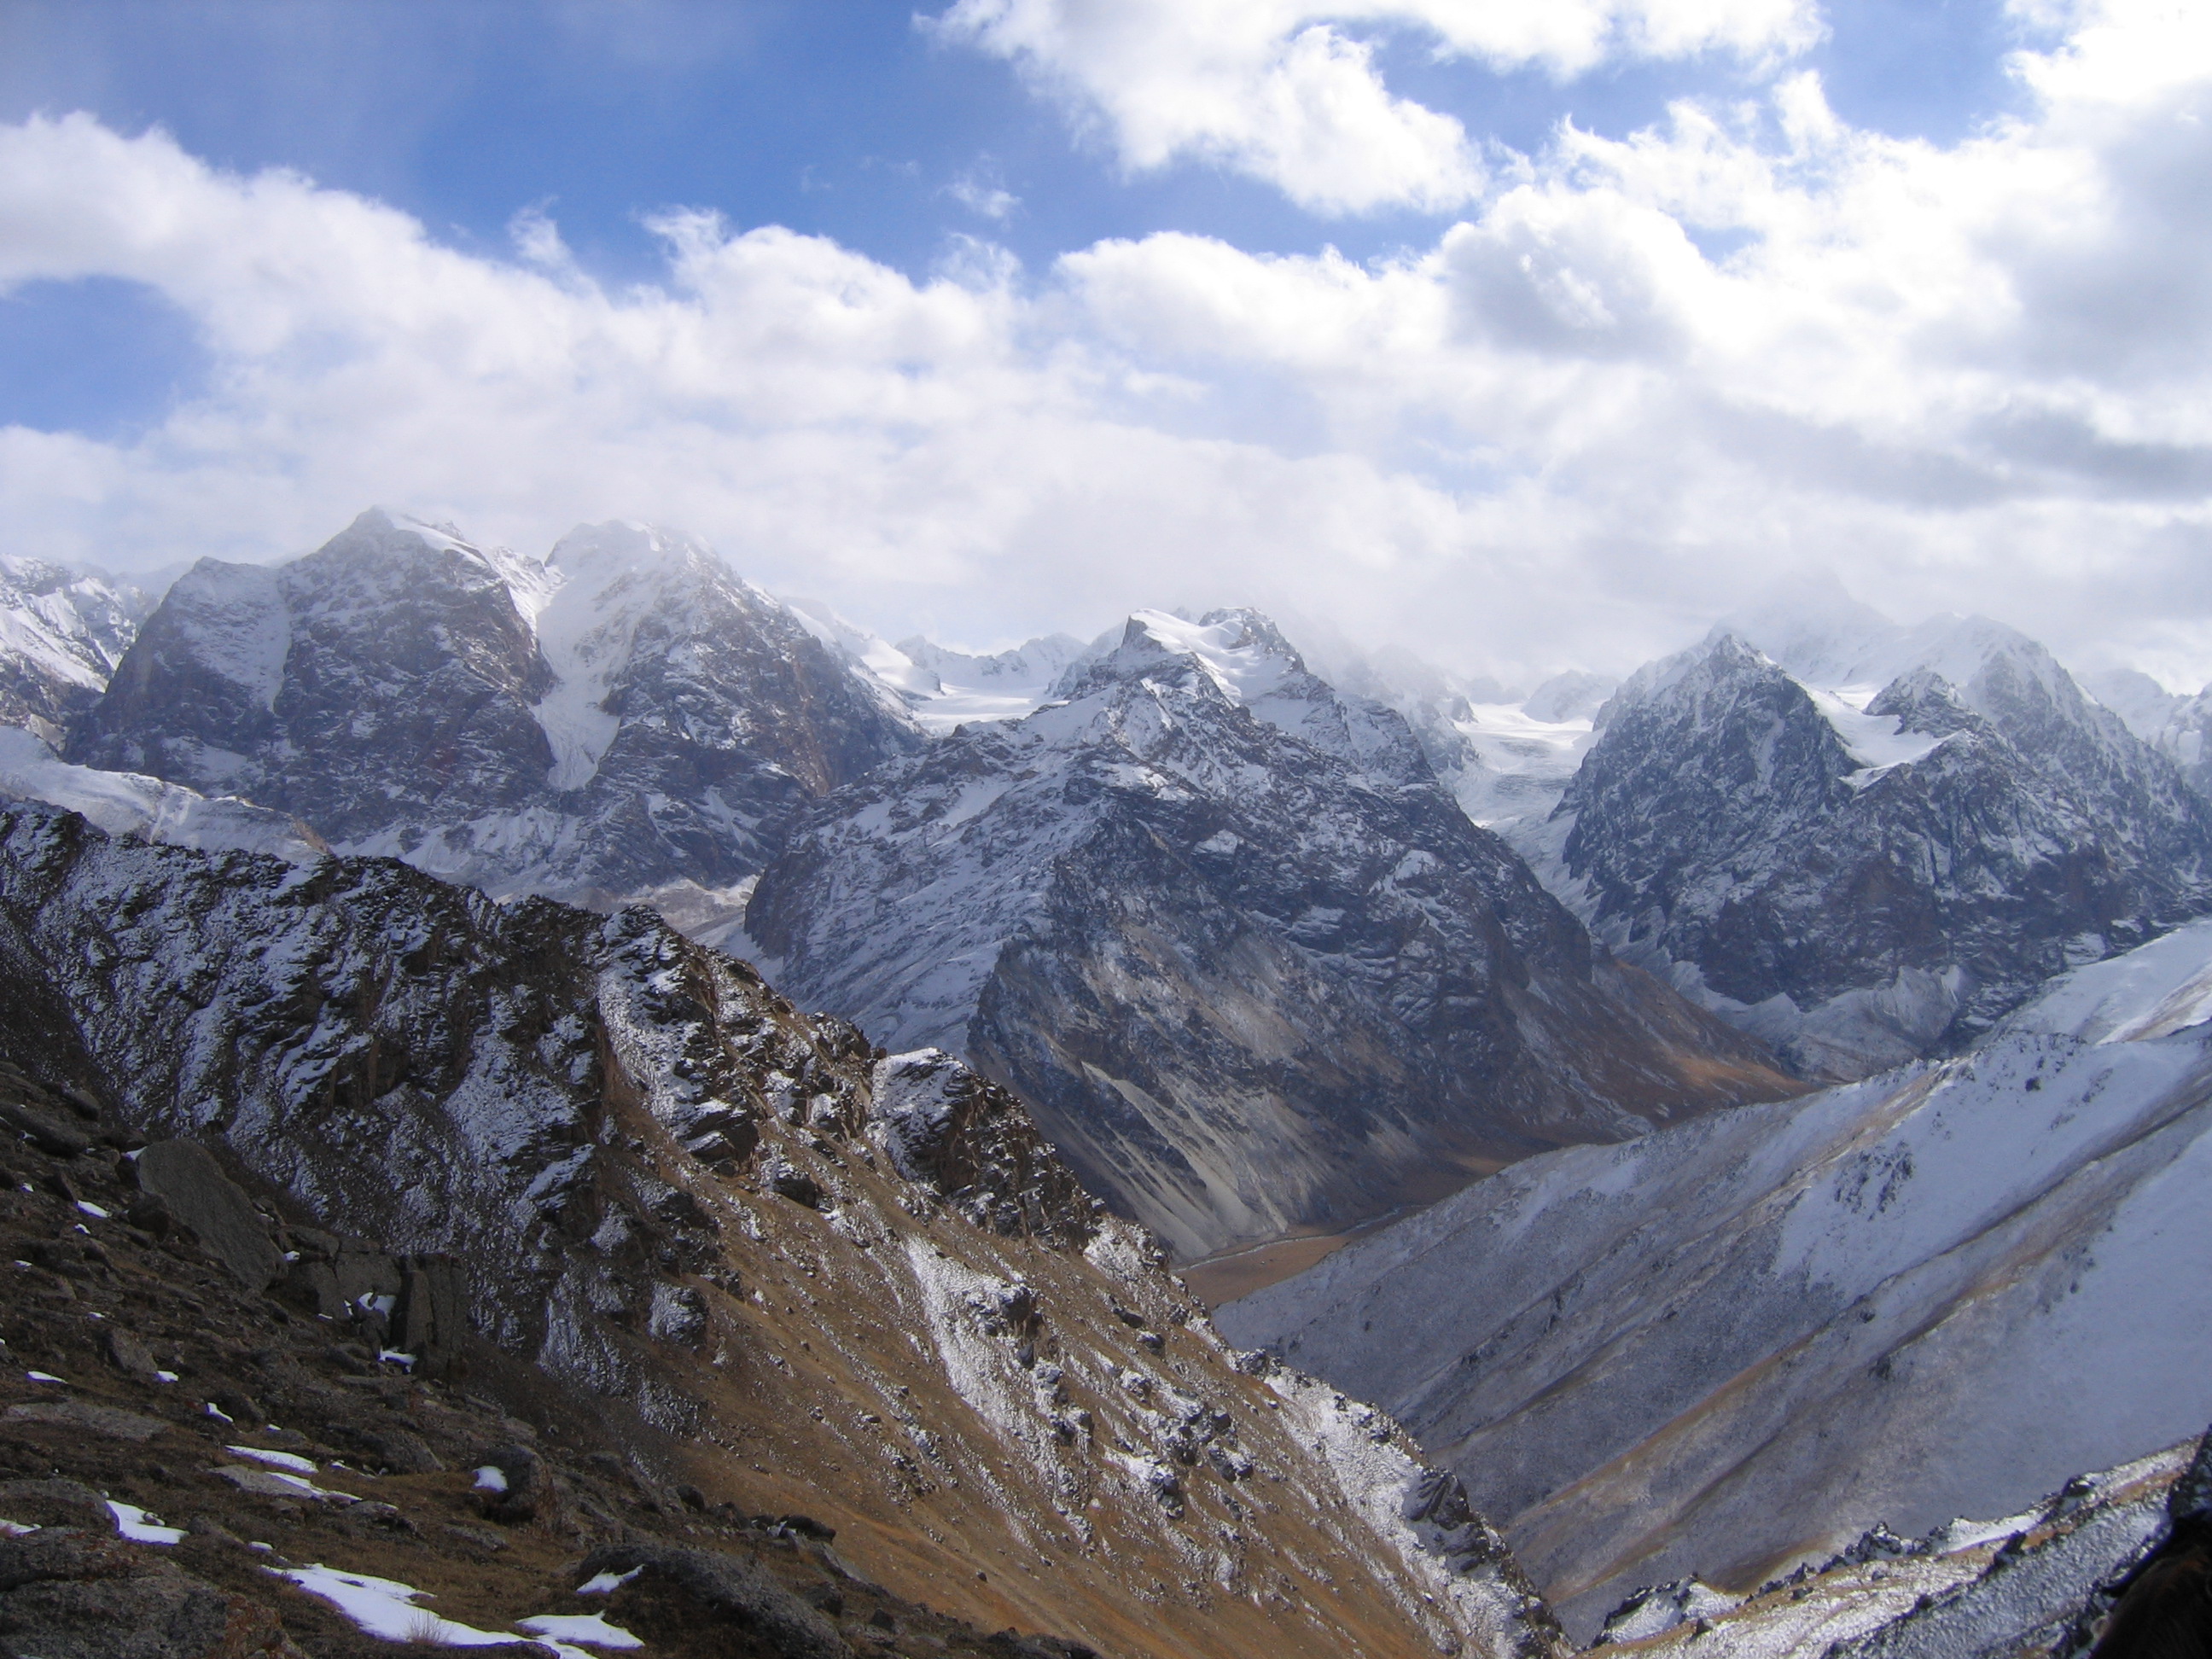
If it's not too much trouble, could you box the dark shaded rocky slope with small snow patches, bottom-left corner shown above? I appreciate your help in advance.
[0,1071,1081,1659]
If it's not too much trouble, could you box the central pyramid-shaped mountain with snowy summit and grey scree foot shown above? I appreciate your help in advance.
[748,610,1787,1256]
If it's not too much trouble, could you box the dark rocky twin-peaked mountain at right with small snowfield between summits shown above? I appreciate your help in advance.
[1557,621,2212,1077]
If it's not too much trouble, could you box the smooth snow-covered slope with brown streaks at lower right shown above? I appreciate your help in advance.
[1217,923,2212,1637]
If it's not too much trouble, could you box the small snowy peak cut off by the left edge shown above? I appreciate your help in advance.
[0,557,154,743]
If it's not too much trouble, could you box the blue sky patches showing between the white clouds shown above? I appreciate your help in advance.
[0,0,2026,434]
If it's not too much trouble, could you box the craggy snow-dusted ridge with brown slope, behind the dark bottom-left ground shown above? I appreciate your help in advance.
[0,810,1555,1659]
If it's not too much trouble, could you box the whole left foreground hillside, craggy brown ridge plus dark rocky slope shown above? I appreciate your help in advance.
[0,807,1557,1659]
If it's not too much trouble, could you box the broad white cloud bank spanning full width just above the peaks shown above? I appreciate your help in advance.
[0,0,2212,684]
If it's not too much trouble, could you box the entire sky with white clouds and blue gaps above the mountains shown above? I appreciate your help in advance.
[0,0,2212,690]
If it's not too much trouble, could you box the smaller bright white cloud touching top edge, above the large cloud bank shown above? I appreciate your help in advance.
[934,0,1820,214]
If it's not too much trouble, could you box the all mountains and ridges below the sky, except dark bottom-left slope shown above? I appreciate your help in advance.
[0,511,2212,1659]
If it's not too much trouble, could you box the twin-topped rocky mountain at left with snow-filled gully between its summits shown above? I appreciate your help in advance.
[68,511,923,900]
